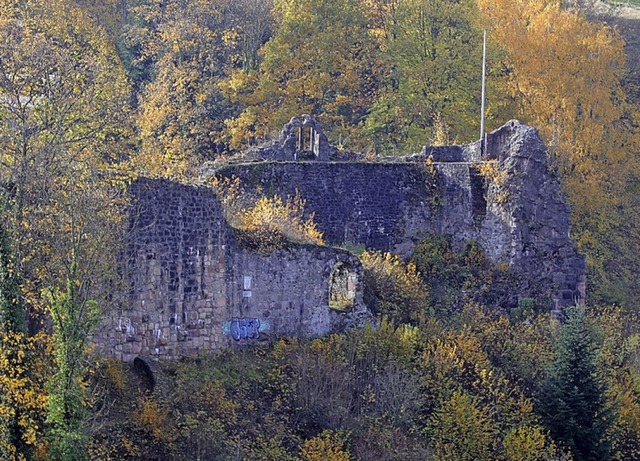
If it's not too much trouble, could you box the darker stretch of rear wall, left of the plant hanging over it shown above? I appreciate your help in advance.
[215,162,435,253]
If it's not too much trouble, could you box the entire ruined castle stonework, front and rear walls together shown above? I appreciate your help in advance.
[94,117,586,360]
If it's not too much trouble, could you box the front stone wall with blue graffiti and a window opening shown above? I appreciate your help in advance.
[93,180,368,360]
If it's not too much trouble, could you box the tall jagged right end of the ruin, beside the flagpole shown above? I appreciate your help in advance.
[479,121,586,309]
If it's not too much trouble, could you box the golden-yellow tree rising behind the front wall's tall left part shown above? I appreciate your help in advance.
[127,0,252,178]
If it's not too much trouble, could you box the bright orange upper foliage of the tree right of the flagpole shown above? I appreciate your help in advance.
[478,0,629,196]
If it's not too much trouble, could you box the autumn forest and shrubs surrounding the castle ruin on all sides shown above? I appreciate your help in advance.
[0,0,640,460]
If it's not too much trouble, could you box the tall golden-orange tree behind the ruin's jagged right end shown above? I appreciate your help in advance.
[478,0,640,305]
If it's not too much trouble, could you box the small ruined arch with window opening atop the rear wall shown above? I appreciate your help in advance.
[278,114,333,162]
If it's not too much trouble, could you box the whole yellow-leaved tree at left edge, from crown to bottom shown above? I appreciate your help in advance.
[0,0,129,459]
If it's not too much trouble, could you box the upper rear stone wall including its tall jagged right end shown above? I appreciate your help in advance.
[215,121,586,309]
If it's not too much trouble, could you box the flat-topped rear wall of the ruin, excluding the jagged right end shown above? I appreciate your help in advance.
[212,158,498,260]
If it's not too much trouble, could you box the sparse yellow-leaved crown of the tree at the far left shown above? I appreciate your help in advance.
[0,0,128,306]
